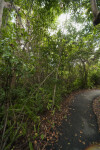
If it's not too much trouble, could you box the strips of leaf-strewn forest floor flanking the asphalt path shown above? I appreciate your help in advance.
[38,89,100,149]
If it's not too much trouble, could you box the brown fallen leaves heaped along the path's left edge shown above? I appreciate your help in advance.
[31,93,76,149]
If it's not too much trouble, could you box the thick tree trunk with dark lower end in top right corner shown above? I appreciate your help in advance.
[91,0,100,26]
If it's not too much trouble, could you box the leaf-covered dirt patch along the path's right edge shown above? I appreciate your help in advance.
[93,97,100,132]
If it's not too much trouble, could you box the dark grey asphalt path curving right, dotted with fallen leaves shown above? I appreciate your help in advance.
[46,90,100,150]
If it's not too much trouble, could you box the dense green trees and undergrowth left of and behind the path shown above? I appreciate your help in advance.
[0,0,100,150]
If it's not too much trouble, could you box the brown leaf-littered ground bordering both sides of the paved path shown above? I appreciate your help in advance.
[34,89,100,150]
